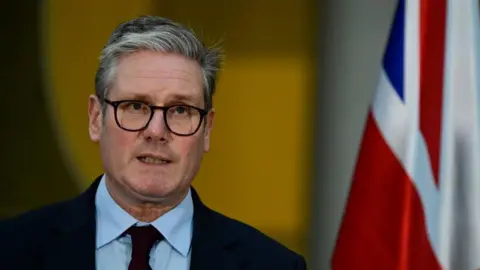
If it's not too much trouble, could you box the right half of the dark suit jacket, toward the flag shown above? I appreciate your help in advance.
[188,190,306,270]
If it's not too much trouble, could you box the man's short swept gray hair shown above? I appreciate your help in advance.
[95,16,221,110]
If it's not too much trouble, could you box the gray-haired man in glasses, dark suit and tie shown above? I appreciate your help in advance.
[0,16,306,270]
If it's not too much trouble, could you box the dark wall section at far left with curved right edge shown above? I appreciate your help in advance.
[0,1,79,218]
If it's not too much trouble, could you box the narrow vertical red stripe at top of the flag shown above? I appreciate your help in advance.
[420,0,447,185]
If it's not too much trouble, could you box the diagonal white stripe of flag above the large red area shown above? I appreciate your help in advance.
[372,67,440,260]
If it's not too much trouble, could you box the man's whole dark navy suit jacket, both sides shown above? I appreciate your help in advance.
[0,178,306,270]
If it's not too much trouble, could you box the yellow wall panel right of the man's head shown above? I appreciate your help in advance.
[194,58,308,231]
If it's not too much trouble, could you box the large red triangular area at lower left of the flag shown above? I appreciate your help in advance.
[332,113,441,270]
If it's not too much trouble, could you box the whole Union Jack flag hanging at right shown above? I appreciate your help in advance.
[332,0,480,270]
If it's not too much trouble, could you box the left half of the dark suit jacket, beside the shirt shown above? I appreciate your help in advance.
[0,180,96,270]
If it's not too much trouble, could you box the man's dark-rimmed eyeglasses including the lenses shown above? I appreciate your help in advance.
[103,99,208,136]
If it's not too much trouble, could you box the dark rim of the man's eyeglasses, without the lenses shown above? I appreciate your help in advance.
[103,98,208,136]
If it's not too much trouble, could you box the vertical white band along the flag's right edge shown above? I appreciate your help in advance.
[438,0,480,270]
